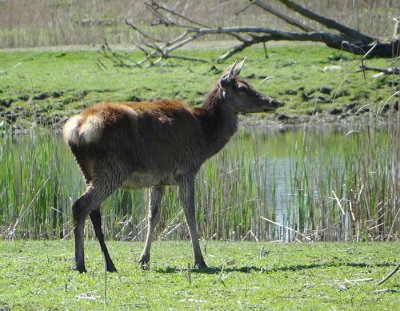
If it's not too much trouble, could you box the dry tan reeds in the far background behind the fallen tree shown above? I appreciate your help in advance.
[0,0,398,48]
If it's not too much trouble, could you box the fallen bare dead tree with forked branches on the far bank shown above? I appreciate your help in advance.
[102,0,400,67]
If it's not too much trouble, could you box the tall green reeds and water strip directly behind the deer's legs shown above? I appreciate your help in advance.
[0,118,400,241]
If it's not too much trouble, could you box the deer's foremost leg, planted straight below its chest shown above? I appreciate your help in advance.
[180,177,207,268]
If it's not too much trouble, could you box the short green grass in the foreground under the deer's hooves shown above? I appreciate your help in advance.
[0,241,400,310]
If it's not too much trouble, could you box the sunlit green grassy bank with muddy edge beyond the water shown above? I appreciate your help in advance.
[0,45,399,128]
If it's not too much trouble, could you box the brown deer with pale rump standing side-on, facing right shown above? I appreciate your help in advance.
[63,60,281,272]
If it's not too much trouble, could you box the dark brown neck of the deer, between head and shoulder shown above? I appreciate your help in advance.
[197,86,238,156]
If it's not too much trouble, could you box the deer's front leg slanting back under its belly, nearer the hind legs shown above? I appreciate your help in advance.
[139,186,164,267]
